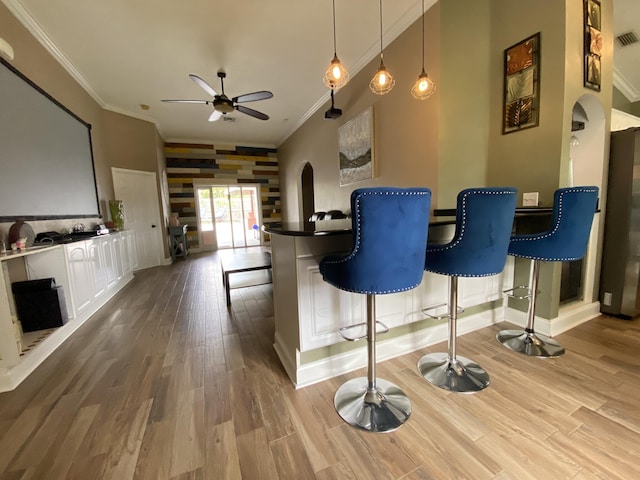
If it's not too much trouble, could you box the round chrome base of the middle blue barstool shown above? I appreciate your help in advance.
[418,353,489,393]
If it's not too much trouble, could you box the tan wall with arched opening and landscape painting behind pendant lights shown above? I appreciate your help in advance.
[278,5,440,221]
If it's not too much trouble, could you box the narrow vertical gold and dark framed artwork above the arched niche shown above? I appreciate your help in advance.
[583,0,602,92]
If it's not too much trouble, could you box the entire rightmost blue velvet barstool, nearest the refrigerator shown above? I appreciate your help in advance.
[496,186,598,358]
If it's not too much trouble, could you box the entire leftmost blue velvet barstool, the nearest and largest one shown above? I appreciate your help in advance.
[320,188,431,432]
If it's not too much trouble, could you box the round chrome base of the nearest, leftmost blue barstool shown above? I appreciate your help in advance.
[333,377,411,432]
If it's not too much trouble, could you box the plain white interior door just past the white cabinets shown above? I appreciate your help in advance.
[111,168,164,269]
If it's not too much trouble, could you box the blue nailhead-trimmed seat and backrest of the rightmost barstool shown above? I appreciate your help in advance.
[509,186,599,262]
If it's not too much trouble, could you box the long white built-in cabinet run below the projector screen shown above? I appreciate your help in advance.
[0,231,137,392]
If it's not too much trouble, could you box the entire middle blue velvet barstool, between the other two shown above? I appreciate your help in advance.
[418,187,517,393]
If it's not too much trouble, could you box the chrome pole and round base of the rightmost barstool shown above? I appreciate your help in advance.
[496,260,564,358]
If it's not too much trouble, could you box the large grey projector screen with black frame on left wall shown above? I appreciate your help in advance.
[0,59,100,221]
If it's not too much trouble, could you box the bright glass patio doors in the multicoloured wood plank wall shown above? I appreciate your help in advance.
[197,185,260,249]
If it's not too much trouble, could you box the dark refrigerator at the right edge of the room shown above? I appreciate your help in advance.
[600,128,640,319]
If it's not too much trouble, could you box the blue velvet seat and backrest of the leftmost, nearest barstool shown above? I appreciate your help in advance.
[320,187,431,294]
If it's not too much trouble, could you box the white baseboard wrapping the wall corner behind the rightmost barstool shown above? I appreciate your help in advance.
[504,302,600,338]
